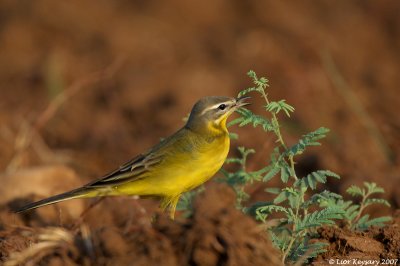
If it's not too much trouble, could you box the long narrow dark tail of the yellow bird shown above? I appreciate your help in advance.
[13,187,91,213]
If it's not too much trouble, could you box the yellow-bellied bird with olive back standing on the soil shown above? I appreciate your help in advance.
[14,96,249,220]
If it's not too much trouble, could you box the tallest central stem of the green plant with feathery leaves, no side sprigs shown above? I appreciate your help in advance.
[225,71,344,262]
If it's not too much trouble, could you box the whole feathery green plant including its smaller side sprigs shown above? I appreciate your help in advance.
[178,71,389,263]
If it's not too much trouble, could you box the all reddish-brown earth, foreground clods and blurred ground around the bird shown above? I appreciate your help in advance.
[0,0,400,265]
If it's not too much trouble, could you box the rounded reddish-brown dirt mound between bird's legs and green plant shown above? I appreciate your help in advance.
[156,186,279,265]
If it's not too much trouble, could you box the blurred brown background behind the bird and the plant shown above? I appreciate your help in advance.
[0,0,400,212]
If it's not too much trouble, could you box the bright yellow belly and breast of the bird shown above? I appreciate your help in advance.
[115,136,229,197]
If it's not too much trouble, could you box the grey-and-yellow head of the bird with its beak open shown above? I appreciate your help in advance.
[186,96,249,133]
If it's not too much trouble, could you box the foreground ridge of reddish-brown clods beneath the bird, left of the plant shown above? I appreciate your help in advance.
[0,185,280,265]
